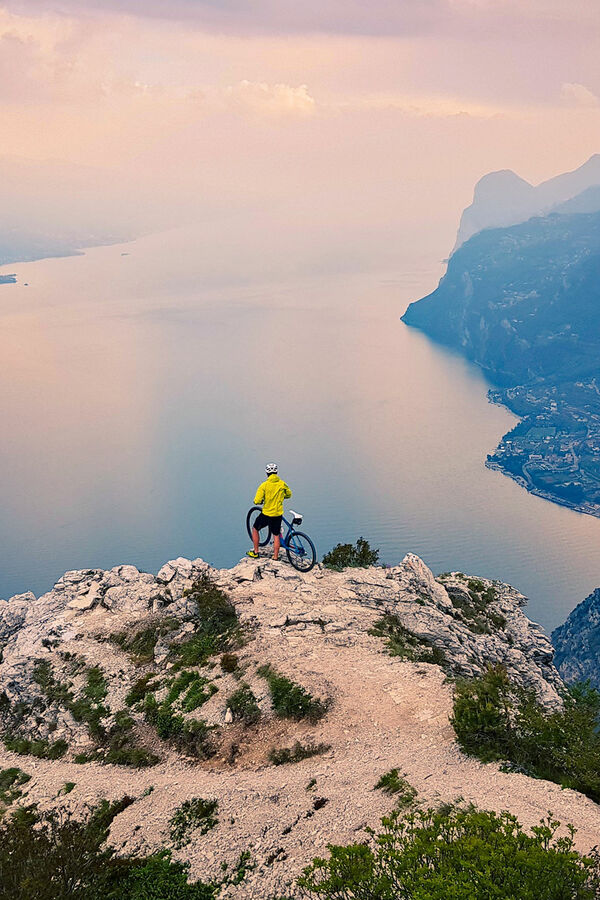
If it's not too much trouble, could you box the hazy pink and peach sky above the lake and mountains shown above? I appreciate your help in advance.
[0,0,600,268]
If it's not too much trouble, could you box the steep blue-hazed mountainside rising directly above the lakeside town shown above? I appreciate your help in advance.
[403,213,600,385]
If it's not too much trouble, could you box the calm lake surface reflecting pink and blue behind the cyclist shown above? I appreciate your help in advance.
[0,233,600,627]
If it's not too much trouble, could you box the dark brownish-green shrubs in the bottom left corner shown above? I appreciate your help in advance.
[0,797,220,900]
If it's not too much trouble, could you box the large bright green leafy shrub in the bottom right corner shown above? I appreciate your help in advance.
[298,808,600,900]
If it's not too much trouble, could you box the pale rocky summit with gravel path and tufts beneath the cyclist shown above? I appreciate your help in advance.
[0,554,600,900]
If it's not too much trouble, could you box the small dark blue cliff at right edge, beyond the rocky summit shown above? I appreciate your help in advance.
[552,588,600,688]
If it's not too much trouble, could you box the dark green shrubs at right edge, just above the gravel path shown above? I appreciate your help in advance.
[452,666,600,803]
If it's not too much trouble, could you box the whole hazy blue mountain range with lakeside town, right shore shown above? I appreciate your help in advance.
[403,155,600,516]
